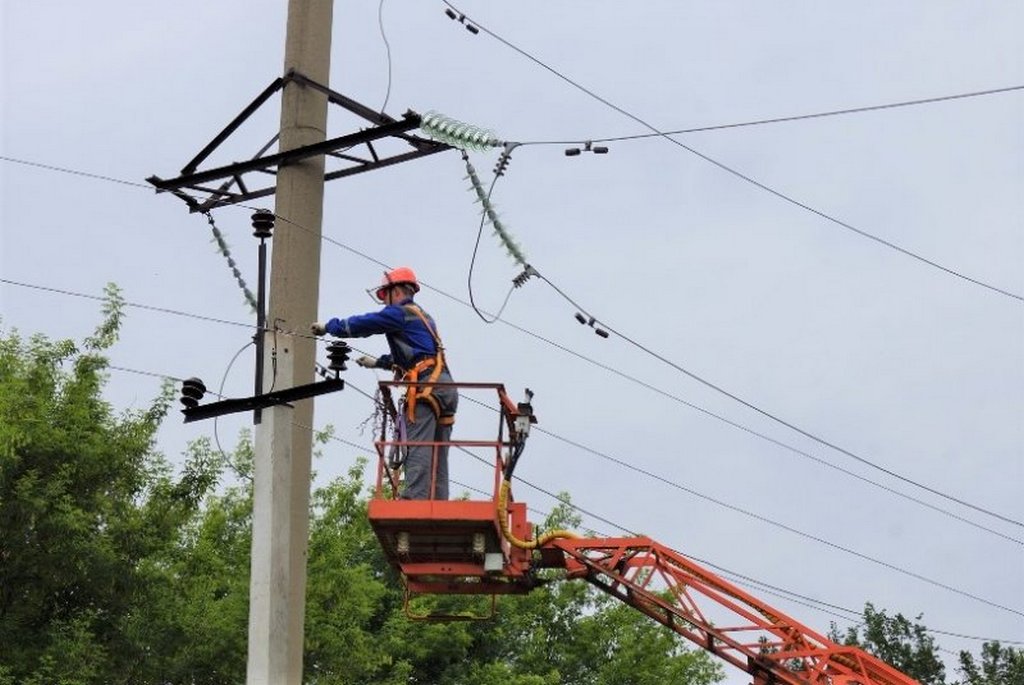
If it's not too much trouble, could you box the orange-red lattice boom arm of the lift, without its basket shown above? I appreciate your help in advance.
[545,538,918,685]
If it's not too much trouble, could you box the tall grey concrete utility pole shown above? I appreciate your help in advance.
[246,0,334,685]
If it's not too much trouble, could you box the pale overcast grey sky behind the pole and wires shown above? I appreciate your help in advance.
[0,0,1024,679]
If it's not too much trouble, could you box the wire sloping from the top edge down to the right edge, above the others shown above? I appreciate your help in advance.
[442,0,1024,303]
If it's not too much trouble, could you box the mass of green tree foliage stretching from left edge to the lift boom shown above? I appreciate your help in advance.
[0,290,722,685]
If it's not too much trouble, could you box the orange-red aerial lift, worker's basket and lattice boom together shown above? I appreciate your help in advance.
[370,382,916,685]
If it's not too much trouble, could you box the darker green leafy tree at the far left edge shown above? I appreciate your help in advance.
[0,287,222,685]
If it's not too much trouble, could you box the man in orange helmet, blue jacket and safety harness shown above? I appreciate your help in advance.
[310,266,459,500]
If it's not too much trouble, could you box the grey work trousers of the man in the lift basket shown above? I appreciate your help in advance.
[401,373,459,500]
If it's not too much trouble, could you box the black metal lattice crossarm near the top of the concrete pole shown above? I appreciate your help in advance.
[146,71,452,212]
